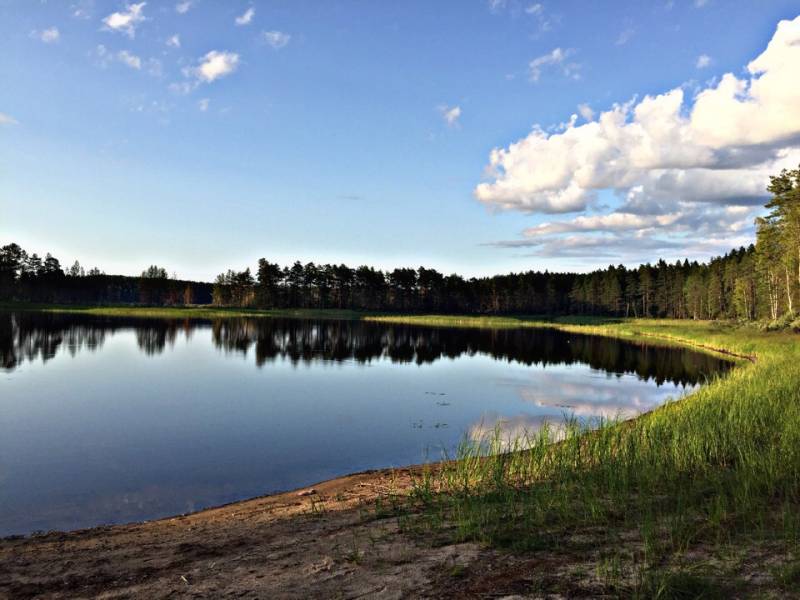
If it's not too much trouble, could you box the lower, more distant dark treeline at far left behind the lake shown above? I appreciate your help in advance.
[0,244,211,306]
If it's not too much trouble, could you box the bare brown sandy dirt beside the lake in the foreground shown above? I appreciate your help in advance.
[0,468,785,600]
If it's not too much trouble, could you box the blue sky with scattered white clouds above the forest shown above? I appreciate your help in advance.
[0,0,800,279]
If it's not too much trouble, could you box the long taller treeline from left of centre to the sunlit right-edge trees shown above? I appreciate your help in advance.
[208,164,800,321]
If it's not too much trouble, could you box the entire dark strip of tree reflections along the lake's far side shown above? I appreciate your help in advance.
[0,313,729,385]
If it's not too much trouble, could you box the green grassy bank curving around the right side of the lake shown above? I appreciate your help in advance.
[364,317,800,598]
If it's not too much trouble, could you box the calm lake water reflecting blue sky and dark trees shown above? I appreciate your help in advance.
[0,312,729,535]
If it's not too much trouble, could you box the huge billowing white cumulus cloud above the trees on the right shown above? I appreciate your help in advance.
[475,17,800,256]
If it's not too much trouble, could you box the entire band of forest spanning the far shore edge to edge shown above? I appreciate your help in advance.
[0,168,800,323]
